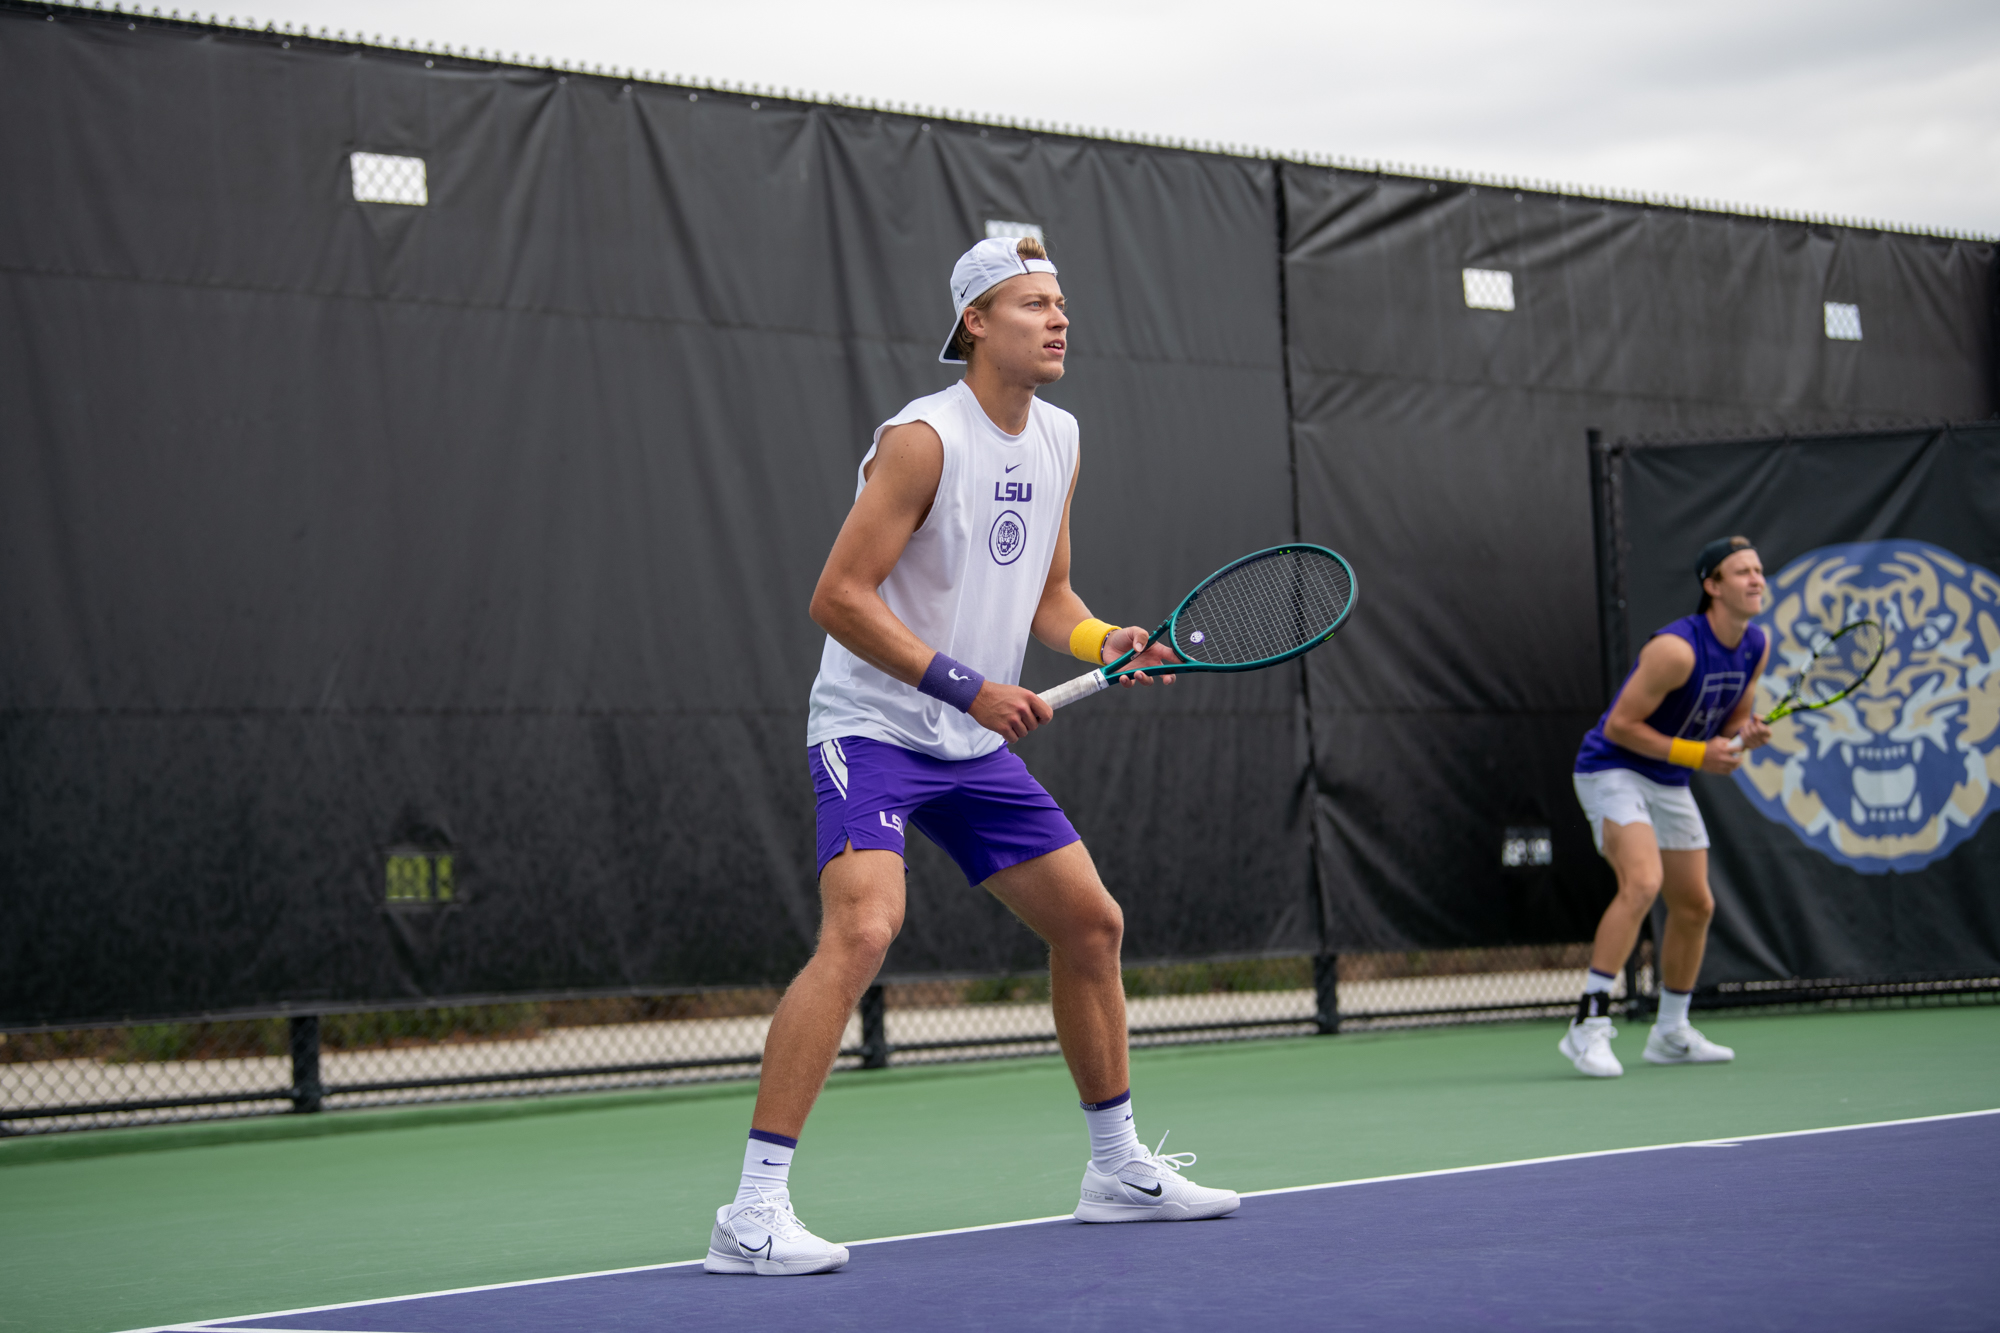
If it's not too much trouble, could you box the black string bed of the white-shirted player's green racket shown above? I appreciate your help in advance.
[1174,550,1354,667]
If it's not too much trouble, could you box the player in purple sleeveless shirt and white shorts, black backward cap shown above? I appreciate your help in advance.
[1556,536,1770,1079]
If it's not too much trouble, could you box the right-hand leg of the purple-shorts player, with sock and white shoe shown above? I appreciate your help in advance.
[986,843,1240,1223]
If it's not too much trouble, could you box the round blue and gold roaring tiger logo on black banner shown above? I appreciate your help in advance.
[1736,540,2000,875]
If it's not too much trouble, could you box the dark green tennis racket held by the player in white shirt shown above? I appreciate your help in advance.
[1042,542,1354,709]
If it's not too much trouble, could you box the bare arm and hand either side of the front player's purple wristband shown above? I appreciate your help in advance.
[812,420,1056,741]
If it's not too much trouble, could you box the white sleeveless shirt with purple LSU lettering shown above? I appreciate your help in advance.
[806,380,1076,759]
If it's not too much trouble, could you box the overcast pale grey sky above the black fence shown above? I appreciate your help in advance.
[254,0,2000,234]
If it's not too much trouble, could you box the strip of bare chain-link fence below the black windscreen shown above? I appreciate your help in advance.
[0,941,2000,1135]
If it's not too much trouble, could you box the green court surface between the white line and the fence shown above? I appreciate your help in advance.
[0,1007,2000,1333]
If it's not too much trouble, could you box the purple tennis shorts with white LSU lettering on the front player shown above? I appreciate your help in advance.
[806,737,1078,885]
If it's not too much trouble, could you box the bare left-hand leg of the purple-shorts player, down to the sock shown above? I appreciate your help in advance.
[750,847,904,1139]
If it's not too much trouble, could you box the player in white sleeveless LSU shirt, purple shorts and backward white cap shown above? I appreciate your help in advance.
[702,238,1238,1275]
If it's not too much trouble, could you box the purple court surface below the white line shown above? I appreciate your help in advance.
[176,1113,2000,1333]
